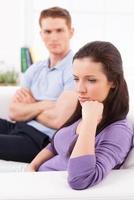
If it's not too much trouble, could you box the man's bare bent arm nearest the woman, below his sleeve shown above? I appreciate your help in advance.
[36,90,78,129]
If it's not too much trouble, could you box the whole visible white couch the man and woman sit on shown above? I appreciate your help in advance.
[0,86,134,200]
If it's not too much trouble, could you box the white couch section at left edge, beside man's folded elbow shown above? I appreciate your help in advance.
[0,86,19,119]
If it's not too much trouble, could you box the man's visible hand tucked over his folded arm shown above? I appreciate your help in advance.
[13,88,36,104]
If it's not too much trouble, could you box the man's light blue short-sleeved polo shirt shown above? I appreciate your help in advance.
[22,51,74,138]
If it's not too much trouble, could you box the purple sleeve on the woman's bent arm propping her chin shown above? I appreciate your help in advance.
[68,126,132,190]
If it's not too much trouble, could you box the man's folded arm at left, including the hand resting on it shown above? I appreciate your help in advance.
[9,88,55,121]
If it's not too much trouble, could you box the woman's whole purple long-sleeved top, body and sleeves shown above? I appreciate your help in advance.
[39,119,133,189]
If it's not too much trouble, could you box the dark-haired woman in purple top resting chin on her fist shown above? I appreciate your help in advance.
[27,41,133,189]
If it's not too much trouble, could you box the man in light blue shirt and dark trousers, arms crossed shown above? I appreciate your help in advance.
[0,7,77,162]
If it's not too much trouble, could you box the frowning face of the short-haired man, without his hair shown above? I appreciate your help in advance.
[41,17,73,55]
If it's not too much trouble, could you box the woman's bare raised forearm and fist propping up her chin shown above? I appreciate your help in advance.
[71,101,103,158]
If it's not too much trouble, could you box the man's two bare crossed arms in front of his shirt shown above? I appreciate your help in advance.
[9,88,77,129]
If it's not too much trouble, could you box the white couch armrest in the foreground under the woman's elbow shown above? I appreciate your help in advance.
[0,170,134,200]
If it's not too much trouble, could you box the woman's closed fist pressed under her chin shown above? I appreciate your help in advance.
[82,101,104,123]
